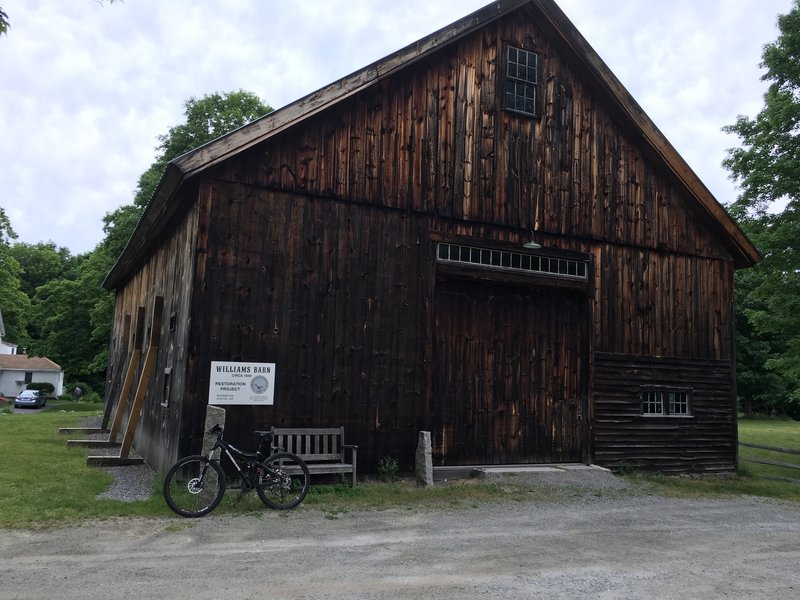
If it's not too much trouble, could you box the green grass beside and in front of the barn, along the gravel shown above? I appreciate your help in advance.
[0,401,800,531]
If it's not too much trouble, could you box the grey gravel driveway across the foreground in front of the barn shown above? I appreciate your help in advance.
[0,478,800,600]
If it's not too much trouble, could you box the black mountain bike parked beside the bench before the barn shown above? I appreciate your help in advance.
[164,425,311,517]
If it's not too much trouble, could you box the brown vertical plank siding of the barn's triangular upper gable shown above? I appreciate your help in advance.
[225,18,728,260]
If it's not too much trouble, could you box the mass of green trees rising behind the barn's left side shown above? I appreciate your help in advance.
[18,91,272,388]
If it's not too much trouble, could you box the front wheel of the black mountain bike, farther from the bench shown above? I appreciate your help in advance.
[164,455,227,517]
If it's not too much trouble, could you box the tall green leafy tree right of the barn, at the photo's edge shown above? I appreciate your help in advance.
[723,0,800,417]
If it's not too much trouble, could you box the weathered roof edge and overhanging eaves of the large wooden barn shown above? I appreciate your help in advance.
[103,0,761,289]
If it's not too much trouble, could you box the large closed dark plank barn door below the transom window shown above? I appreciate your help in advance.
[432,279,585,465]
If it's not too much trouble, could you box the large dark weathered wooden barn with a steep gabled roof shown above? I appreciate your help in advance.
[105,0,760,472]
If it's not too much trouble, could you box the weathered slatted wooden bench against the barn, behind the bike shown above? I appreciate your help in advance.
[272,427,358,485]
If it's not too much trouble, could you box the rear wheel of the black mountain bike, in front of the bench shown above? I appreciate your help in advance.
[256,452,311,510]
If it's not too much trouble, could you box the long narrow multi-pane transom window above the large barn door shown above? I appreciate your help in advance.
[436,242,589,280]
